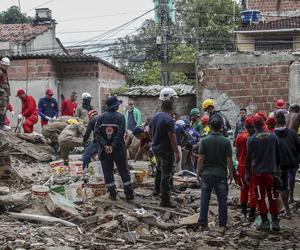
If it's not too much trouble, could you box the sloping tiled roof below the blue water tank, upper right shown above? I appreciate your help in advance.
[234,16,300,33]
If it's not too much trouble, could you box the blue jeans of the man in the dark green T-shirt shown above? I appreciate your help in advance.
[199,175,228,227]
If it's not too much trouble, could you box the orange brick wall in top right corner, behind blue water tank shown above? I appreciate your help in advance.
[247,0,300,12]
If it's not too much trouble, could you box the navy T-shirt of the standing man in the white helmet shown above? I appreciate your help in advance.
[150,112,175,154]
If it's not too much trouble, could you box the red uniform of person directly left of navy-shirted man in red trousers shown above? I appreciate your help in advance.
[235,130,256,208]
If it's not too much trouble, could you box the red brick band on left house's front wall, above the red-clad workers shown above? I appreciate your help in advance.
[8,59,56,80]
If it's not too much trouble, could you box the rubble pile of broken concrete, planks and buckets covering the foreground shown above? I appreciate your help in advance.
[0,139,300,249]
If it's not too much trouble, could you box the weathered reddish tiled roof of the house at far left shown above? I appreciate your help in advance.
[0,24,52,42]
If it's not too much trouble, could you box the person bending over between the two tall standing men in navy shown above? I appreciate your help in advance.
[132,126,151,161]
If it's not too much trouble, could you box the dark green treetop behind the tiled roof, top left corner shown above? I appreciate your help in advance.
[0,5,32,24]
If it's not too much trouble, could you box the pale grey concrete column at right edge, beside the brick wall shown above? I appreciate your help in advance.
[289,62,300,104]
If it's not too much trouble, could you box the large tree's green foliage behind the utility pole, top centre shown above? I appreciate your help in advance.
[111,0,240,85]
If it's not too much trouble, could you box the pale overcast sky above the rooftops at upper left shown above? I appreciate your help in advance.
[0,0,154,46]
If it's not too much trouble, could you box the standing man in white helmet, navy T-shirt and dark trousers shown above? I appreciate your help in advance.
[149,87,180,208]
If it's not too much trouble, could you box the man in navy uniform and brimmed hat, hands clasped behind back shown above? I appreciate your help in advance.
[95,96,134,200]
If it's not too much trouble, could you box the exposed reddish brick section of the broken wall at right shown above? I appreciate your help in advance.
[202,62,290,112]
